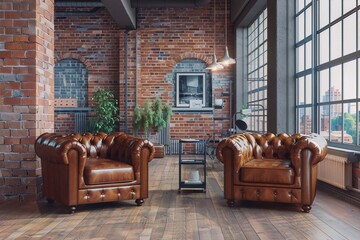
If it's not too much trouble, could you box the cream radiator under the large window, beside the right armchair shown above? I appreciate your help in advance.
[317,149,352,189]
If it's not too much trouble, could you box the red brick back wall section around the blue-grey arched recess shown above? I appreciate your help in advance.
[55,7,120,106]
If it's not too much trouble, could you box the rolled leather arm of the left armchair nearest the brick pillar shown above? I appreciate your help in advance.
[35,133,87,165]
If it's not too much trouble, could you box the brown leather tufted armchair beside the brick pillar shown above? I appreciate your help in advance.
[35,132,155,212]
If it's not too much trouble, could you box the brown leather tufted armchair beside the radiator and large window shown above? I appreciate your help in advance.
[216,133,327,212]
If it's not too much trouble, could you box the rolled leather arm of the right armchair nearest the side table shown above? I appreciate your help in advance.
[216,134,253,172]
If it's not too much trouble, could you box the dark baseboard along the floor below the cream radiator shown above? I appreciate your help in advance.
[317,180,360,207]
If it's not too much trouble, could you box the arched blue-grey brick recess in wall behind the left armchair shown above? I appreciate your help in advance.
[55,59,88,107]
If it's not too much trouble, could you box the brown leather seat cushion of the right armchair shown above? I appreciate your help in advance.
[240,159,294,184]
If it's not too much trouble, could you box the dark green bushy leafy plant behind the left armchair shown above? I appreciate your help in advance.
[92,88,119,133]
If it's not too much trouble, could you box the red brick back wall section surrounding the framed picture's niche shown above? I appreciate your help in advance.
[119,1,234,139]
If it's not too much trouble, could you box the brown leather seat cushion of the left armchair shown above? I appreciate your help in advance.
[84,158,134,185]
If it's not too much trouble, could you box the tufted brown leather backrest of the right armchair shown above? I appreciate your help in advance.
[252,133,302,159]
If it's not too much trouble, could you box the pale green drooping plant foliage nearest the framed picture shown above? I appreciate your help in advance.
[133,97,172,138]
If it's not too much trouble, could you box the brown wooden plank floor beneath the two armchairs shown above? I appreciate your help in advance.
[0,156,360,240]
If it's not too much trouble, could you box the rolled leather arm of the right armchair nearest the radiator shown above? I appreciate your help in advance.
[291,133,327,168]
